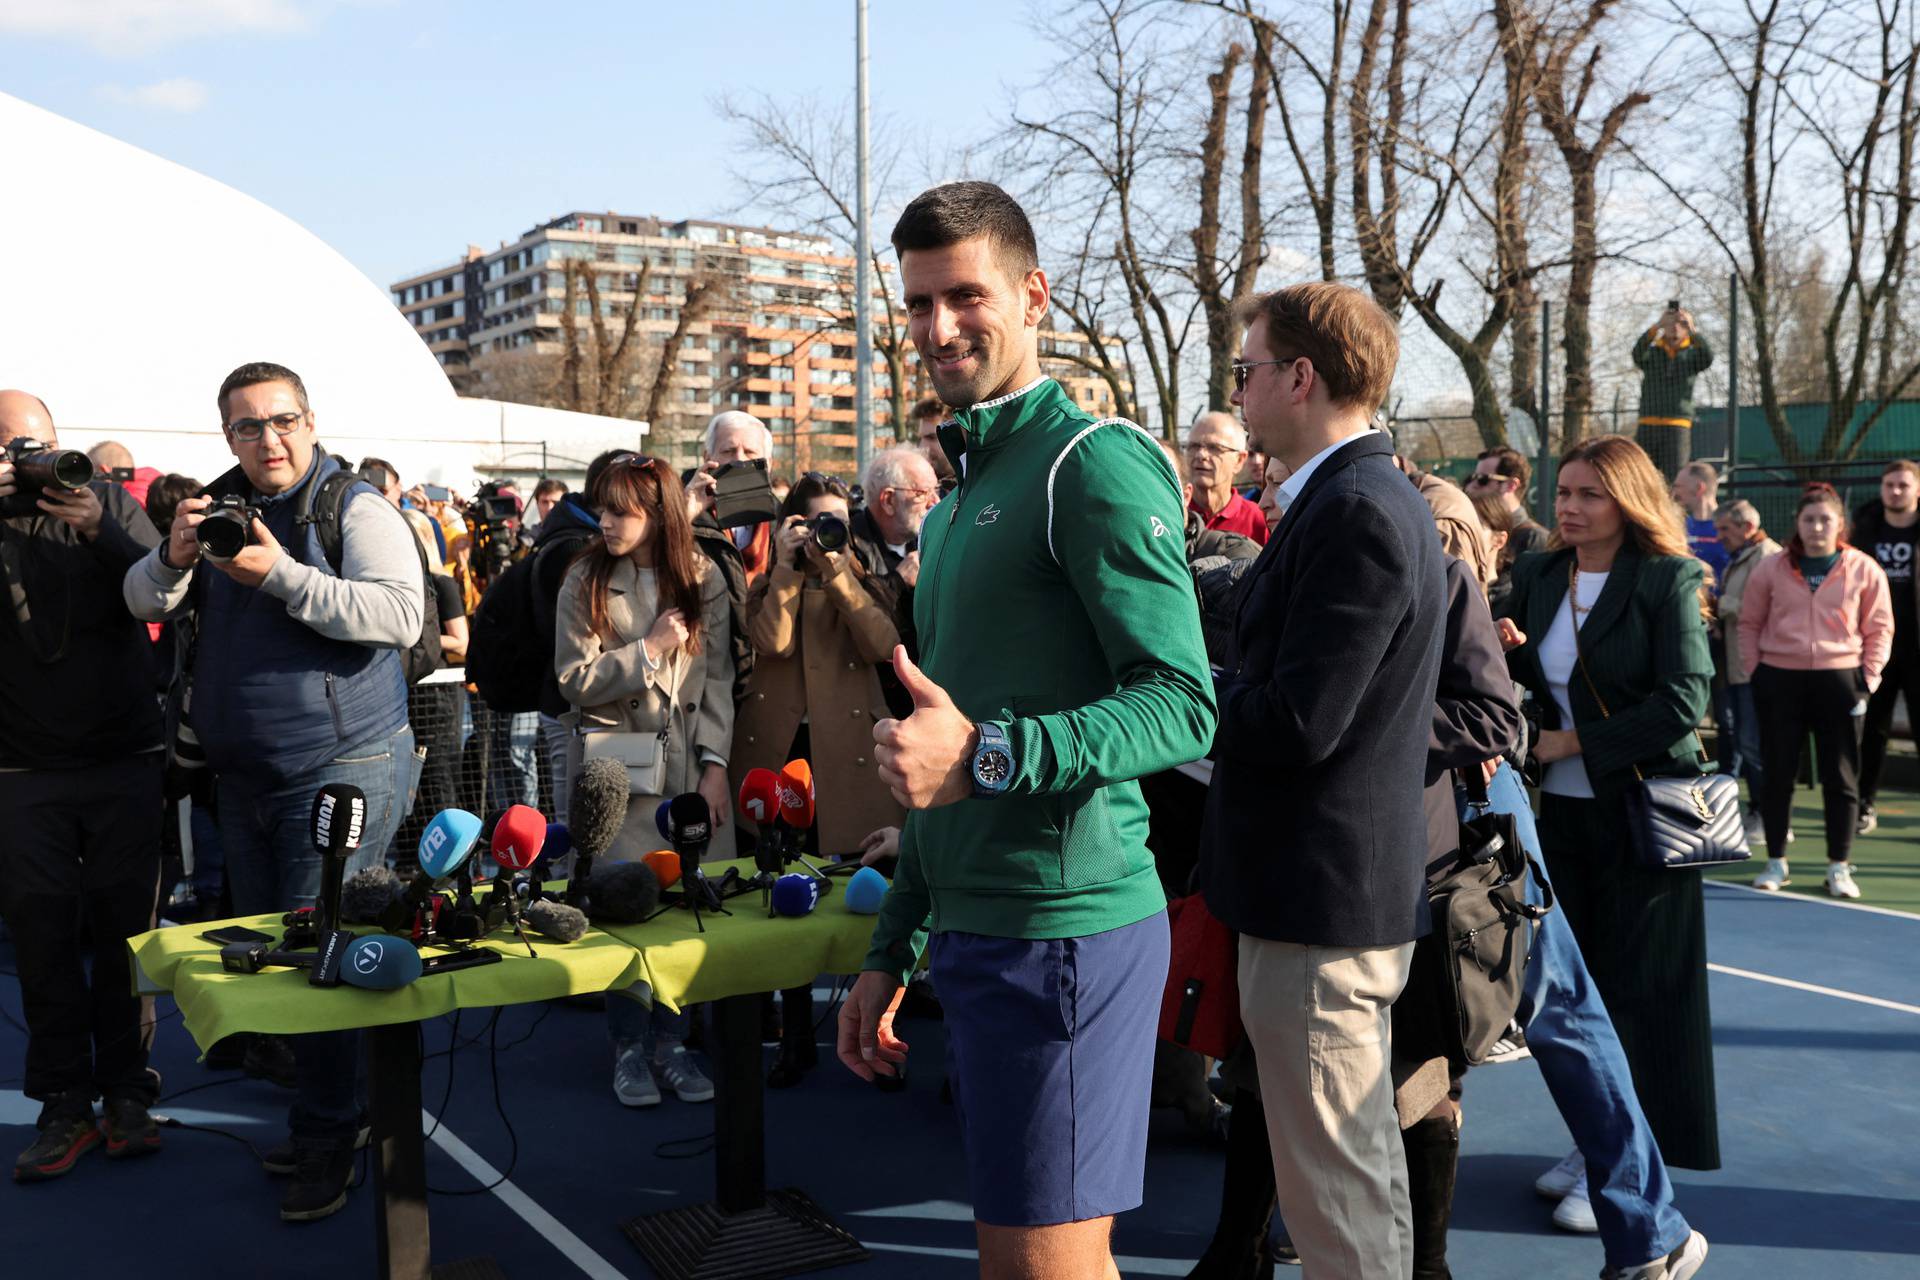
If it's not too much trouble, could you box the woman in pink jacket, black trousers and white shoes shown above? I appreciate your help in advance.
[1740,484,1893,898]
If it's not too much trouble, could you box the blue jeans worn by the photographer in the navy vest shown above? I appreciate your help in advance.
[221,727,417,1144]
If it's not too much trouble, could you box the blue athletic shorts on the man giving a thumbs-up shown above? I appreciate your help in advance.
[931,912,1167,1226]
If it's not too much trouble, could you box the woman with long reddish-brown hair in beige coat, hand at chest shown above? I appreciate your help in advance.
[553,455,733,1107]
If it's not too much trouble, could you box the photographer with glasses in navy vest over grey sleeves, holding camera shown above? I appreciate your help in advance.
[123,363,424,1222]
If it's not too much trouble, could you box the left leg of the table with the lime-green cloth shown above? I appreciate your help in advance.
[367,1023,432,1280]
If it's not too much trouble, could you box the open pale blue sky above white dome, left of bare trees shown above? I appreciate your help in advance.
[0,0,1056,284]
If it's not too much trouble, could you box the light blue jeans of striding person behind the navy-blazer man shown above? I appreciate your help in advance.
[1488,759,1697,1268]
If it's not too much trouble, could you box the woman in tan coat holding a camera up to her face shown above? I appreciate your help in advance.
[733,472,902,1088]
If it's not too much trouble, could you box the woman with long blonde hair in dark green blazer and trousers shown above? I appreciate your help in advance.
[1500,436,1720,1169]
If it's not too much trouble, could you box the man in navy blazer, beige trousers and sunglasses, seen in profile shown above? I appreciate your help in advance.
[1200,284,1446,1280]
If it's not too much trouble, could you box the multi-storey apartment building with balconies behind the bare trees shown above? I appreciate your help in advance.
[390,213,1112,474]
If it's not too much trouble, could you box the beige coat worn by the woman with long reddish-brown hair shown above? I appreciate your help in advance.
[553,557,733,860]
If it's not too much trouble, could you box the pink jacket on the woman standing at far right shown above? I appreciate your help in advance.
[1740,547,1893,689]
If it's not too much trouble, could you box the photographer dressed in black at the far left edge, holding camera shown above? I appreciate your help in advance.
[0,391,165,1182]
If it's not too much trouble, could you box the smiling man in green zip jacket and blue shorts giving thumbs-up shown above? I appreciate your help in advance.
[839,182,1213,1280]
